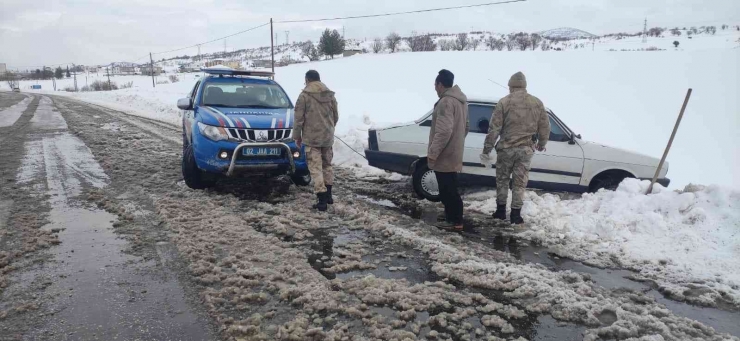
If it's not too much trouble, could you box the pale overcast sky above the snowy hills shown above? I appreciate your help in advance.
[0,0,740,68]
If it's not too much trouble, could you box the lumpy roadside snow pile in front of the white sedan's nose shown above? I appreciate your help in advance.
[516,179,740,305]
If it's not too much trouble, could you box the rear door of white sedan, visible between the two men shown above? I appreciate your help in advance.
[462,102,496,177]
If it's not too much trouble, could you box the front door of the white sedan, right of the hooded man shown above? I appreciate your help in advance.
[528,112,584,186]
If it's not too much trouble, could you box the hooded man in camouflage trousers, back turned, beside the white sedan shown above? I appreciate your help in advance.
[481,72,550,224]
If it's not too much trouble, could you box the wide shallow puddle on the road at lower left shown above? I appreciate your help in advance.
[28,205,209,340]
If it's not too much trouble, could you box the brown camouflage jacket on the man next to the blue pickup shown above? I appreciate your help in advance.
[293,82,339,147]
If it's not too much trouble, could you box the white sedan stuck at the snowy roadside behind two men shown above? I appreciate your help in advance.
[365,99,670,201]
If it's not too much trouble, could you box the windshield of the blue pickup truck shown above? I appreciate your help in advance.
[203,83,292,109]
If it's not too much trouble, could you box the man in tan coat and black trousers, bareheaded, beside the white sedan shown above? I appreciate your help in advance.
[427,70,468,231]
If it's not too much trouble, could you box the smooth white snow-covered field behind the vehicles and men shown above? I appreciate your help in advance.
[13,49,740,188]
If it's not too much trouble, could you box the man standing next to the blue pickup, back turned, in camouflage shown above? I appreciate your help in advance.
[293,70,339,211]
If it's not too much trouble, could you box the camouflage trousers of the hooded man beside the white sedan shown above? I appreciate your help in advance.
[496,146,534,209]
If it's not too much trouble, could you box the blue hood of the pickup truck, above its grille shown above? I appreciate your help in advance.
[198,106,294,129]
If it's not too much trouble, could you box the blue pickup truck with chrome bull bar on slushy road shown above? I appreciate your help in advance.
[177,69,311,189]
